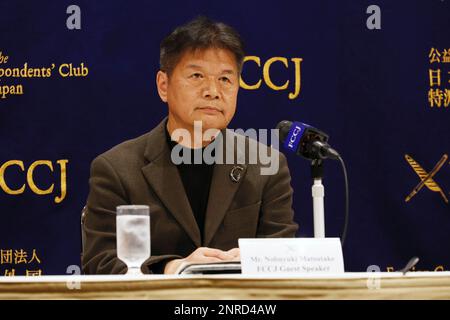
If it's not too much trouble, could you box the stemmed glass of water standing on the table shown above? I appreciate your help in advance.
[116,205,150,274]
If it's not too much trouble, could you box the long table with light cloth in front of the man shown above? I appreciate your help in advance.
[0,272,450,300]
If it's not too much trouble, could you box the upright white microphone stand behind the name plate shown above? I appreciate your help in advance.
[311,159,325,238]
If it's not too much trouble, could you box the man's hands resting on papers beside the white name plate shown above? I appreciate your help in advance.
[164,247,240,274]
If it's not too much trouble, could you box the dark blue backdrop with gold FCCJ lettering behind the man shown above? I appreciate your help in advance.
[0,0,450,275]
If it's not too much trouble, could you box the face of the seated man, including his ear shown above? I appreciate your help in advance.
[157,48,239,131]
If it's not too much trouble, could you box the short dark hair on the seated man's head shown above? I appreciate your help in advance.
[159,16,245,74]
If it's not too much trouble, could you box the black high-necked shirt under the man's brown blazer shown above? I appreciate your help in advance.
[166,127,214,241]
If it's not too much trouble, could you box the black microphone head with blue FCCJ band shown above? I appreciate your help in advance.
[276,120,340,160]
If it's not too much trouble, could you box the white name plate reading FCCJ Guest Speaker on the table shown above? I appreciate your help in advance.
[239,238,344,275]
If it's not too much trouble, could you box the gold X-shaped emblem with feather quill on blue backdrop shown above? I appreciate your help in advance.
[405,154,448,203]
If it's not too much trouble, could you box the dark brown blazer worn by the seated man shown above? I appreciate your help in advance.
[82,119,297,274]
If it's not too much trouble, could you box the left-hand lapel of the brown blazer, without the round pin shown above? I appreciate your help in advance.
[142,119,201,247]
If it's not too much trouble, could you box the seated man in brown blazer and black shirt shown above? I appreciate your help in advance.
[82,18,297,274]
